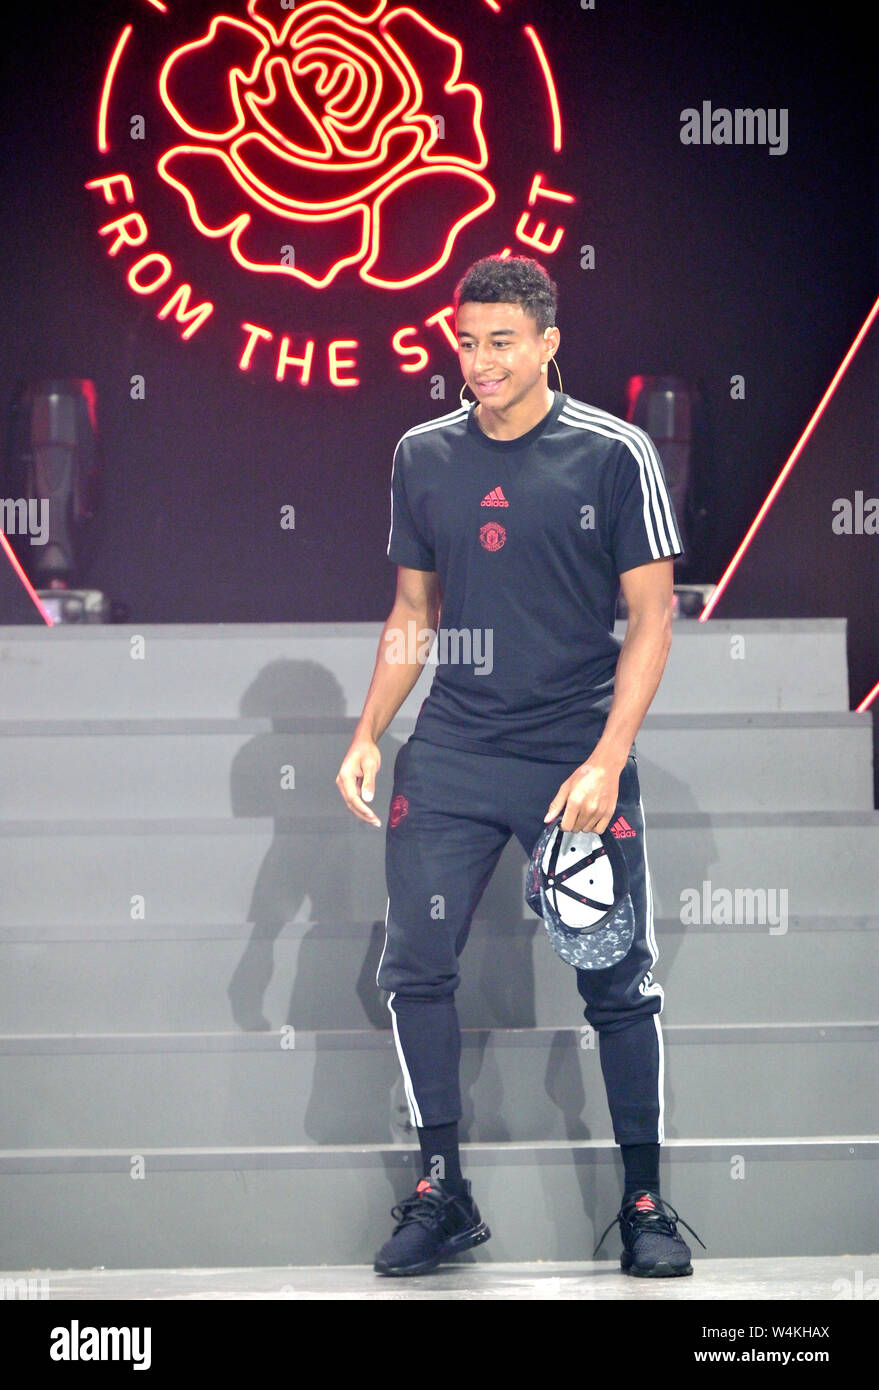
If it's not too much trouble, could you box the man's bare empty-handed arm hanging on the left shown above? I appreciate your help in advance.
[335,564,440,826]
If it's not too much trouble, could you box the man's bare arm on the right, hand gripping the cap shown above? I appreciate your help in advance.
[544,560,675,834]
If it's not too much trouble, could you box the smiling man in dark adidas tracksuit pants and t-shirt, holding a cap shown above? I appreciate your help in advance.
[337,256,700,1276]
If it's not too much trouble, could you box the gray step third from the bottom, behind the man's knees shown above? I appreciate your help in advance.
[0,911,879,1033]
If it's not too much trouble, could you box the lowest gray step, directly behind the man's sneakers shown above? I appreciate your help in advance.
[0,1136,879,1273]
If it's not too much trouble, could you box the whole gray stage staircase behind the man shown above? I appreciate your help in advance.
[0,620,879,1269]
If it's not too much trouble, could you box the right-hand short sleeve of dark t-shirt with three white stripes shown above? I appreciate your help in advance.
[611,425,684,574]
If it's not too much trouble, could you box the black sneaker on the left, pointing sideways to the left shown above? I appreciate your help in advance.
[373,1177,491,1275]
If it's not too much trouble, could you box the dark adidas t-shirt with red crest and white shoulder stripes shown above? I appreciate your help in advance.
[385,392,683,763]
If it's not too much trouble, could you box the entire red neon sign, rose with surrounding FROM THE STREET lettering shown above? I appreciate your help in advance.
[86,0,574,386]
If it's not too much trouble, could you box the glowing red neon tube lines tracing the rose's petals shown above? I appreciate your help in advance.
[157,0,497,289]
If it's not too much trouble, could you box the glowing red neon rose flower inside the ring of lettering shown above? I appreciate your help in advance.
[159,3,495,289]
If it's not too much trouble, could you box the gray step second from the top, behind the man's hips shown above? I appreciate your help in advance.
[0,713,873,820]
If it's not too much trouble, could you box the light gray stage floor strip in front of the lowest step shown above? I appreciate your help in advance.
[8,1255,879,1302]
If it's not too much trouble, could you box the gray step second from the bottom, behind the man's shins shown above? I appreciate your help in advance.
[0,1023,879,1151]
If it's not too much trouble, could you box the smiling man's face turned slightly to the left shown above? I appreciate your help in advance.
[455,300,556,411]
